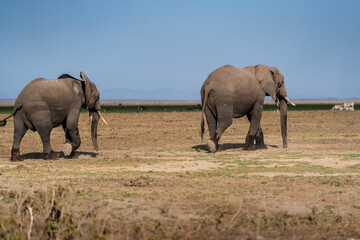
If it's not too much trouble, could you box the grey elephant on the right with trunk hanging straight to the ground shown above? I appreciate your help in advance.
[201,65,295,152]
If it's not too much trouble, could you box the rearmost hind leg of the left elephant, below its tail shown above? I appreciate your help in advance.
[10,114,28,162]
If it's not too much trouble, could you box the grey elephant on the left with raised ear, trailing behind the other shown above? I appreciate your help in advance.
[0,72,107,161]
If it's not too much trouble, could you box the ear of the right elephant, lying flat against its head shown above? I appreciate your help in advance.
[255,65,276,101]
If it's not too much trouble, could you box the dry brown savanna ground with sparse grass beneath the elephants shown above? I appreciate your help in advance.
[0,108,360,239]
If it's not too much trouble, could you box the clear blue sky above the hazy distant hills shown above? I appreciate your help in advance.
[0,0,360,98]
